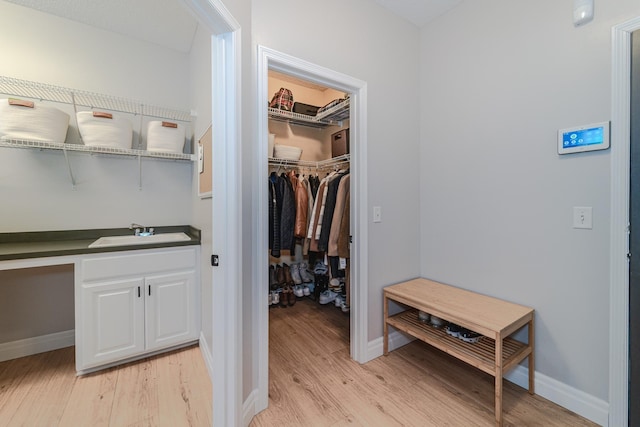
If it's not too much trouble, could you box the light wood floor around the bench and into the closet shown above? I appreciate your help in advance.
[251,299,595,427]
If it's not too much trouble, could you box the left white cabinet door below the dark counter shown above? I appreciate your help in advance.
[82,277,144,368]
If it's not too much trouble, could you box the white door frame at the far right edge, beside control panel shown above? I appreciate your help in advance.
[609,13,640,427]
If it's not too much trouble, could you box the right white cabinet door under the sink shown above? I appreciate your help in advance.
[145,271,198,350]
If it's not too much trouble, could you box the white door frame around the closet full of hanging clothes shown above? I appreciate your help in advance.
[252,46,368,412]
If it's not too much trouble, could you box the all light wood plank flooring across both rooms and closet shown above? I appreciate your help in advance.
[0,299,595,427]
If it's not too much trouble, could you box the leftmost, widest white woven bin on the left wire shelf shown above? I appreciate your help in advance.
[0,98,70,144]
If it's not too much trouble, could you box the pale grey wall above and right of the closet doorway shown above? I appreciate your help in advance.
[252,0,419,352]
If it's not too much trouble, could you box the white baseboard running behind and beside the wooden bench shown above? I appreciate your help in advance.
[367,331,609,427]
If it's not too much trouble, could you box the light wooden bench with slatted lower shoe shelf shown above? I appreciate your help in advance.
[383,279,535,426]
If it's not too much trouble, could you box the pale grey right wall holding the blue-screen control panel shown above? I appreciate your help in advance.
[420,0,640,401]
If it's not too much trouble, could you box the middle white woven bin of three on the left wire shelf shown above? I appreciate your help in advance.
[76,111,133,149]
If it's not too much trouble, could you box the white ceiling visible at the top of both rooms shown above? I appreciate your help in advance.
[6,0,462,53]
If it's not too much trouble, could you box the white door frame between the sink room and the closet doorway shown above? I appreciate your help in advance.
[182,0,242,426]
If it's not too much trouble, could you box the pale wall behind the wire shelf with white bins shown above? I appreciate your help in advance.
[0,2,193,232]
